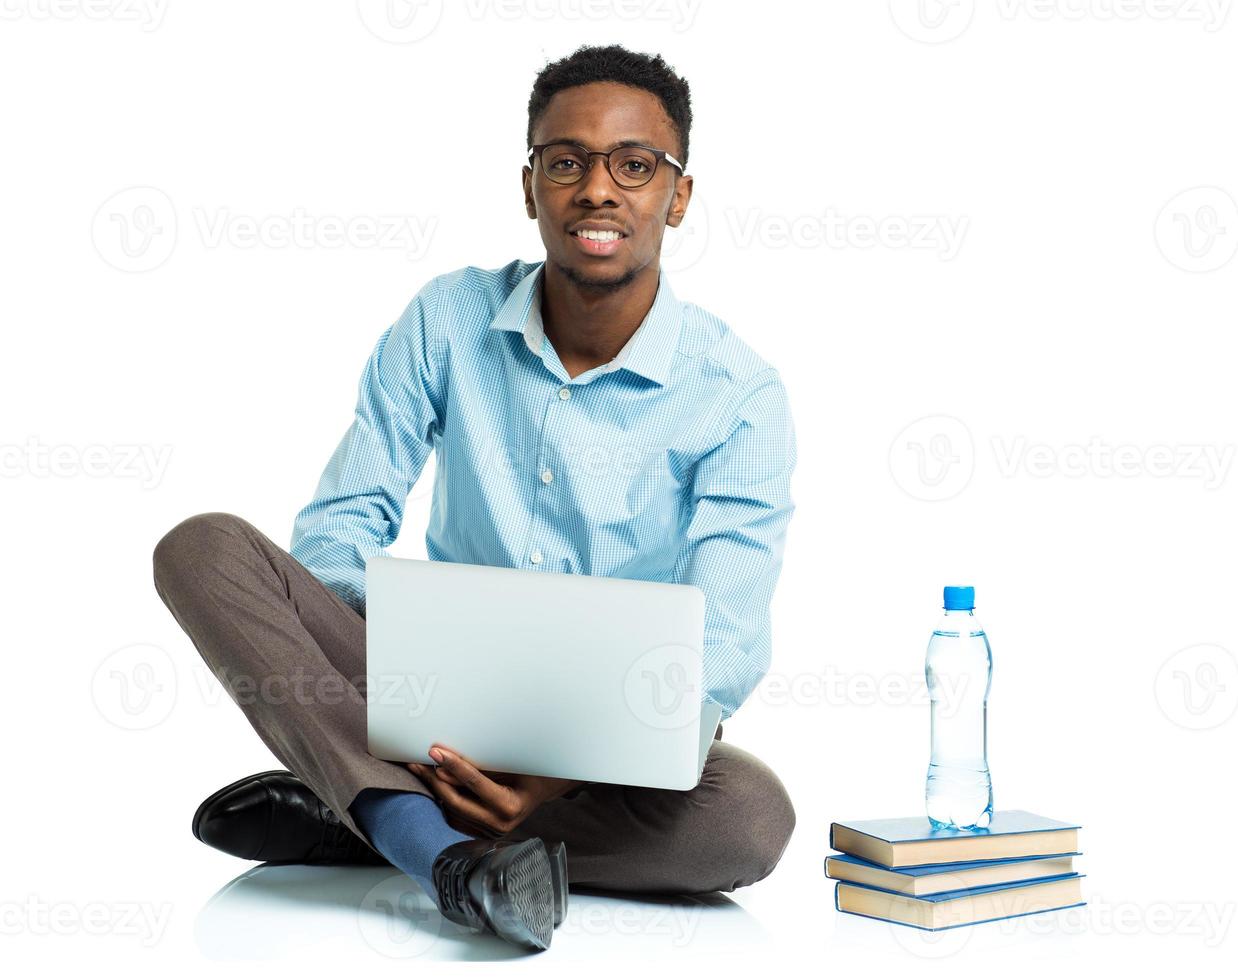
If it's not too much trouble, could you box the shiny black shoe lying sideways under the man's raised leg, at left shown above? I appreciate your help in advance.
[193,770,387,865]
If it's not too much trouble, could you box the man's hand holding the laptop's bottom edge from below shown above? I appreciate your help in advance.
[406,744,583,836]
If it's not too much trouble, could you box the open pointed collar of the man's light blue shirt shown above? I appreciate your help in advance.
[490,261,682,385]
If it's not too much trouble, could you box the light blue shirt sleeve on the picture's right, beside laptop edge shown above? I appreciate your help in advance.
[676,369,796,720]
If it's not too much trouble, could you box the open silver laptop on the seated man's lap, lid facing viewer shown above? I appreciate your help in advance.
[365,557,722,789]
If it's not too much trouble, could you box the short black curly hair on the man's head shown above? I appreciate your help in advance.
[525,45,692,167]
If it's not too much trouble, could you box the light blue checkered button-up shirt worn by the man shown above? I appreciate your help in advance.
[291,260,796,720]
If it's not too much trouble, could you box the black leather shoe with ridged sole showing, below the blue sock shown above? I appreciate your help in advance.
[431,838,555,949]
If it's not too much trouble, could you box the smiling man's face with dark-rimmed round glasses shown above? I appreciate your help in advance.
[522,82,692,291]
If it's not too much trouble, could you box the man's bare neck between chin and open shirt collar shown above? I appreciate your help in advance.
[540,260,659,377]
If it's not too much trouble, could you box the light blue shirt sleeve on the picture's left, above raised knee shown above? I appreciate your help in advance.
[290,281,444,615]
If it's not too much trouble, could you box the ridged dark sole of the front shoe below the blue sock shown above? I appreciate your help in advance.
[483,838,555,949]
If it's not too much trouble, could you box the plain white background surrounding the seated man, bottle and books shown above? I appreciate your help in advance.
[0,0,1238,976]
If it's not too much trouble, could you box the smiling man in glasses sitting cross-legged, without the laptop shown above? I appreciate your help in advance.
[155,46,796,949]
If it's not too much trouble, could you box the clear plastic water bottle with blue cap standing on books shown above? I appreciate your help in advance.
[925,585,993,830]
